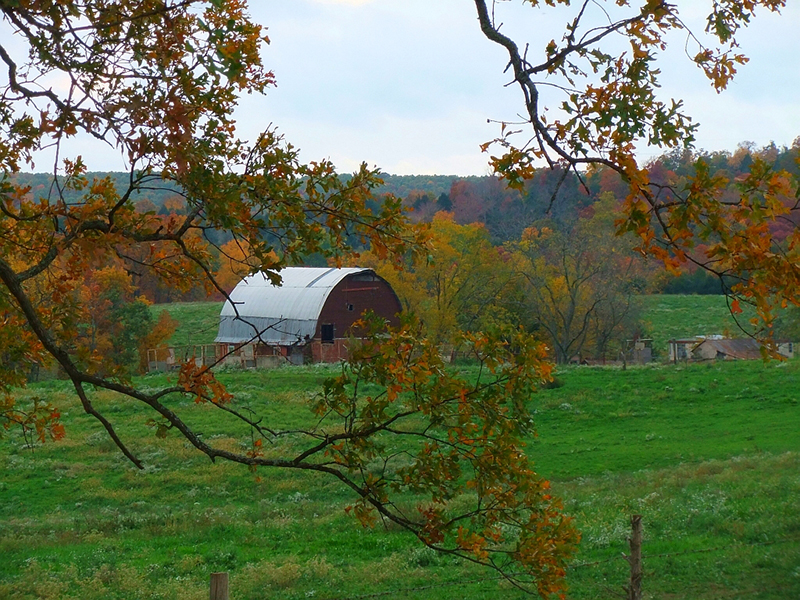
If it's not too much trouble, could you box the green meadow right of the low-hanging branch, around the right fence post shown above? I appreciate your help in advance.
[529,362,800,599]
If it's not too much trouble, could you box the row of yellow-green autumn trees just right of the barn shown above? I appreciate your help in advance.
[359,194,662,363]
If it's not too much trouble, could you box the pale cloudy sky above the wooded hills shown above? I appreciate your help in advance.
[6,0,800,175]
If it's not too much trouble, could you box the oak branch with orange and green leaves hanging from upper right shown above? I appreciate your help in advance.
[475,0,800,336]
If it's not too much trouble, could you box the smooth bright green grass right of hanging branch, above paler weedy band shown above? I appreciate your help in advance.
[532,361,800,479]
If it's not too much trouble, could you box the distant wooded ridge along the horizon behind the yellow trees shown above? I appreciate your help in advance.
[14,143,800,302]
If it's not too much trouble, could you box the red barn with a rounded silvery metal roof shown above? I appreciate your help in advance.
[215,267,401,367]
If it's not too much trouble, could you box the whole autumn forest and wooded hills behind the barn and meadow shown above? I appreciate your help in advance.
[16,143,800,370]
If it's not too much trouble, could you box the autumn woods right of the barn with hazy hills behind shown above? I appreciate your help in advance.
[361,145,800,363]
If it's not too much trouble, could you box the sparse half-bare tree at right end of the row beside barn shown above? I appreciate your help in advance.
[515,196,644,363]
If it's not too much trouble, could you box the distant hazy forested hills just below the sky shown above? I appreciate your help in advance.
[13,138,800,258]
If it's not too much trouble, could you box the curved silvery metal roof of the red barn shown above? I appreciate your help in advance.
[215,267,372,346]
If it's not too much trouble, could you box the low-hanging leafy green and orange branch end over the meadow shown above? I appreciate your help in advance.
[314,317,577,595]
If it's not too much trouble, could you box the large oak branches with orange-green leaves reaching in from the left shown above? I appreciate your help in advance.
[0,0,577,596]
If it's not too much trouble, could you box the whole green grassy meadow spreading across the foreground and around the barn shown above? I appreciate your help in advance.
[0,297,800,600]
